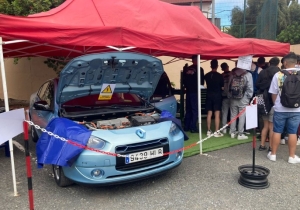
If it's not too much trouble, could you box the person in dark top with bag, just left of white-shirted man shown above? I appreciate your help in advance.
[255,57,280,151]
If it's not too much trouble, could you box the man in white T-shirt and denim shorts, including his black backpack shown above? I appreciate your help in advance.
[267,52,300,164]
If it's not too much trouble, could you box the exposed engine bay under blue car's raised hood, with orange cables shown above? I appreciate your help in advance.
[74,111,160,130]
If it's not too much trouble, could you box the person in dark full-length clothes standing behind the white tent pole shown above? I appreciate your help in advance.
[183,55,204,133]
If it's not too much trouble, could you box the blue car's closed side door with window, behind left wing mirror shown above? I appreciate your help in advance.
[31,80,55,134]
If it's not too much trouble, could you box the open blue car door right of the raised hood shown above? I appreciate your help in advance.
[150,72,177,117]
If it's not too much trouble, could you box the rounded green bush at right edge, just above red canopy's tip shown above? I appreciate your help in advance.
[277,23,300,44]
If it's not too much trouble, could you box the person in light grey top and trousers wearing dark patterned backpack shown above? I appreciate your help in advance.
[228,68,253,140]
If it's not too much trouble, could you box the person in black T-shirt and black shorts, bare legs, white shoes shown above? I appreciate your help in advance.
[204,59,224,137]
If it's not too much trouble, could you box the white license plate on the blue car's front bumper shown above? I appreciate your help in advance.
[125,147,164,164]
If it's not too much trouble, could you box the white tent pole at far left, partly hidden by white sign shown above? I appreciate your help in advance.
[0,37,18,196]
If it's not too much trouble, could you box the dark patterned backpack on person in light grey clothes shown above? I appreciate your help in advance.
[229,71,247,99]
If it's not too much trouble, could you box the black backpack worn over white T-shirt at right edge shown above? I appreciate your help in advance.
[279,70,300,108]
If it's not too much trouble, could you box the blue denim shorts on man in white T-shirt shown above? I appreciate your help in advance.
[273,111,300,134]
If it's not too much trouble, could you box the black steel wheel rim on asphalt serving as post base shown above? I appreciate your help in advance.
[238,165,270,189]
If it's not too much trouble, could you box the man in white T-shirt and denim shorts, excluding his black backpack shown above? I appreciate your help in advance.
[267,52,300,164]
